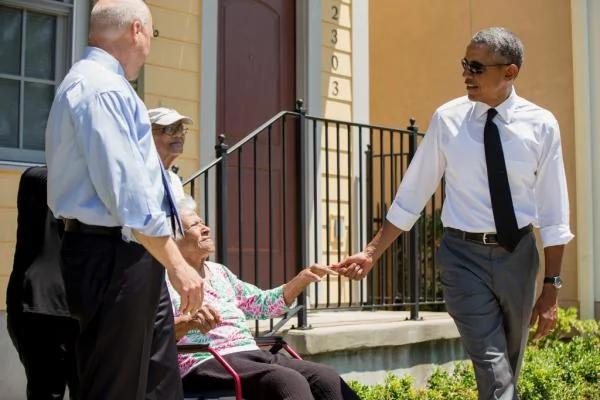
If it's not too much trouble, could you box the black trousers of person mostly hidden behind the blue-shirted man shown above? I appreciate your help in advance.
[7,310,79,400]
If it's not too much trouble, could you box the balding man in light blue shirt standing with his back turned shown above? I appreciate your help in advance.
[46,0,203,400]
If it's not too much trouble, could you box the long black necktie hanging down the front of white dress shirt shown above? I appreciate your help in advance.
[483,108,519,252]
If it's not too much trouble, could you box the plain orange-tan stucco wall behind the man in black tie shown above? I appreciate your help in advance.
[369,0,577,305]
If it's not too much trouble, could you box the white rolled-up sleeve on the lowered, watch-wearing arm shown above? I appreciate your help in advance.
[535,118,574,247]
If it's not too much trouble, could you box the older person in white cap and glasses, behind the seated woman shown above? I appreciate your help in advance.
[148,107,194,203]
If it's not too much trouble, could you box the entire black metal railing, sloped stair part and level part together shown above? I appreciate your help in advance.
[184,101,443,333]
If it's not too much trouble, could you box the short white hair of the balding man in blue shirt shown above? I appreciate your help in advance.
[90,0,150,37]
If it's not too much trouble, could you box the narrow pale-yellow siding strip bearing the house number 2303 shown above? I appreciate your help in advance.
[318,0,357,304]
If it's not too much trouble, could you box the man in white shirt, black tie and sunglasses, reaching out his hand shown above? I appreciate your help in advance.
[337,28,573,399]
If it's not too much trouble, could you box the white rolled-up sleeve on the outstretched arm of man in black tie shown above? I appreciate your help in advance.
[386,113,446,231]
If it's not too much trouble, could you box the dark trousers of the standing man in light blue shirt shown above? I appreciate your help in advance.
[61,232,183,400]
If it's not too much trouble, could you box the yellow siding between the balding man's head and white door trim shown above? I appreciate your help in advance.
[144,0,202,184]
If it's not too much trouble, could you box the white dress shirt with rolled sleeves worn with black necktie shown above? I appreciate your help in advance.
[387,90,573,247]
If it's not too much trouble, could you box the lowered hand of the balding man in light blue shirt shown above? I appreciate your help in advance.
[167,264,204,314]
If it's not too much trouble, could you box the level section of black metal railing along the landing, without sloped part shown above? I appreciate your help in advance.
[306,116,443,319]
